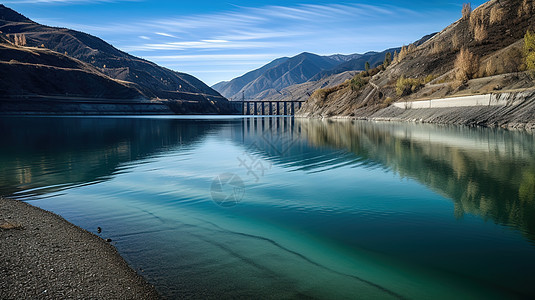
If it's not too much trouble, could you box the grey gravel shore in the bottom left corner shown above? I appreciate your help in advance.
[0,198,158,299]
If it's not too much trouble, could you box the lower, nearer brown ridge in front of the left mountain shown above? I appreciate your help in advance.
[0,39,142,99]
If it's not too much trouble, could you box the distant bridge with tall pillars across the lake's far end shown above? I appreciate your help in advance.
[230,101,305,116]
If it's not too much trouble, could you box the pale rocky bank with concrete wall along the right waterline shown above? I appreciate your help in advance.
[296,89,535,130]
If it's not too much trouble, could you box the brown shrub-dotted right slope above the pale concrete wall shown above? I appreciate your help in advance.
[298,0,535,126]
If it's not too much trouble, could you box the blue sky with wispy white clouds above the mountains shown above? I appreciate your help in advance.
[2,0,485,85]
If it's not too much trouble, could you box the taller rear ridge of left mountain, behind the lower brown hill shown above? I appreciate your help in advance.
[0,4,227,111]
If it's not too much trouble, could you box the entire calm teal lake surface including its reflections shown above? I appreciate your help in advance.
[0,117,535,299]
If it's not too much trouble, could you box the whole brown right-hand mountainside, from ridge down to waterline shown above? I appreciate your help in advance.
[298,0,535,126]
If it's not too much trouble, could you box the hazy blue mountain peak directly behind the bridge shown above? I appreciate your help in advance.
[214,52,340,99]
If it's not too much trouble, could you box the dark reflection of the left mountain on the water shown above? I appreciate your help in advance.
[0,117,224,197]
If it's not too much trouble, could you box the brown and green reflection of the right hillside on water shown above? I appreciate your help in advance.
[296,119,535,240]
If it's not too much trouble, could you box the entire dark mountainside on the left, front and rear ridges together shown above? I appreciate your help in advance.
[0,4,227,113]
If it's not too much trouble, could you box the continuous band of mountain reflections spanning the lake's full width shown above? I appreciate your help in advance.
[0,117,535,240]
